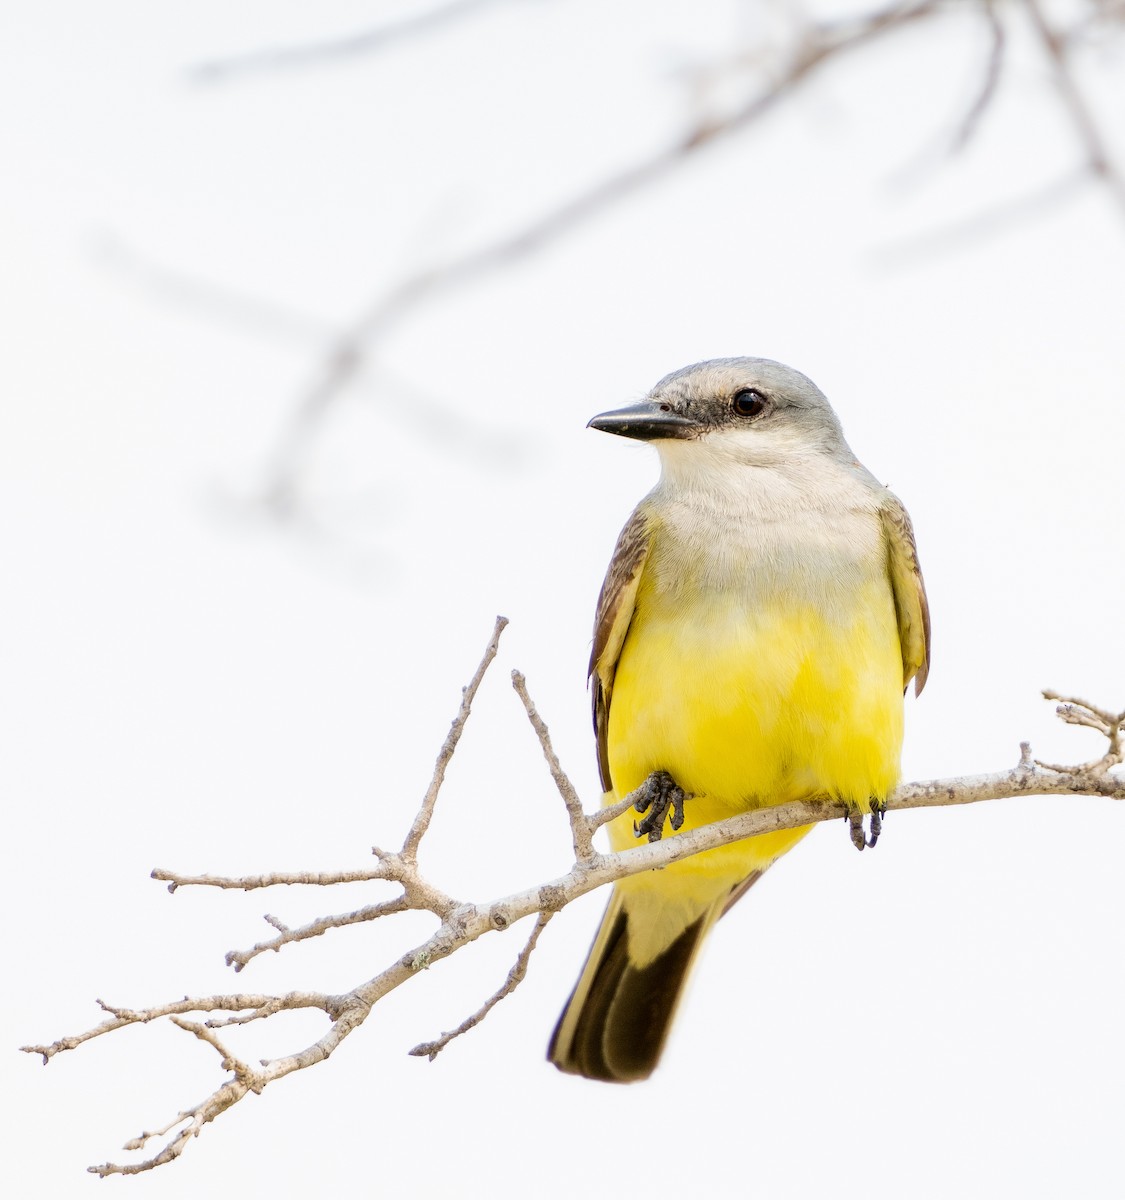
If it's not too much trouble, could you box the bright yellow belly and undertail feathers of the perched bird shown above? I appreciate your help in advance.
[607,578,902,962]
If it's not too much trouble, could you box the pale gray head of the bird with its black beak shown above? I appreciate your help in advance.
[590,359,850,467]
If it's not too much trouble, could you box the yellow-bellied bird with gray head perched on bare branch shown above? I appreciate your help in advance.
[548,358,930,1082]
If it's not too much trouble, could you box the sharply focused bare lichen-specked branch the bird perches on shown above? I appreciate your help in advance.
[23,618,1125,1176]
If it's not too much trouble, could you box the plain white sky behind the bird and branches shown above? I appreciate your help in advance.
[0,0,1125,1200]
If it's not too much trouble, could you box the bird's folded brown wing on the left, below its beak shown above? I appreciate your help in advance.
[590,509,651,792]
